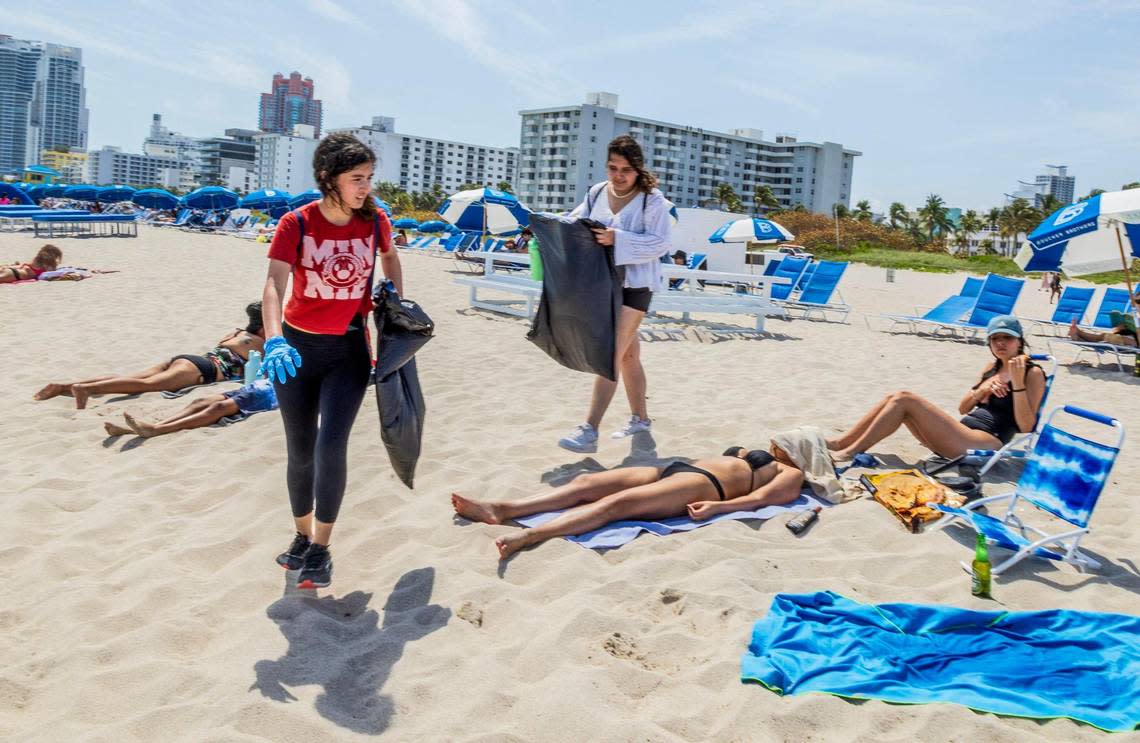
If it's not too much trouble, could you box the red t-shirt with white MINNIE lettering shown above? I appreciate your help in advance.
[269,202,392,335]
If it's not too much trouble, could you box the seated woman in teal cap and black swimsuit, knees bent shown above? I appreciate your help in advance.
[828,315,1045,460]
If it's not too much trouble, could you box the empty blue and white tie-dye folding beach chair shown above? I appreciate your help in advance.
[937,406,1124,575]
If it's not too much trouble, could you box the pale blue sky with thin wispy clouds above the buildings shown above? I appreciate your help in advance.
[8,0,1140,210]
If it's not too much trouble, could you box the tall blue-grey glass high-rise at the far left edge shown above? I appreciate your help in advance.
[0,35,88,172]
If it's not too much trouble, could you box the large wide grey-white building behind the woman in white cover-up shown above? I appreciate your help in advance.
[518,92,862,213]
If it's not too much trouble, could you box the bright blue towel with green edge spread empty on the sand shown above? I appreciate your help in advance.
[741,591,1140,733]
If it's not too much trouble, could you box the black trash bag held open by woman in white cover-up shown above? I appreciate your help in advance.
[527,214,622,381]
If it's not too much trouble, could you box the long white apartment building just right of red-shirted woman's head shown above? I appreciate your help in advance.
[332,116,519,194]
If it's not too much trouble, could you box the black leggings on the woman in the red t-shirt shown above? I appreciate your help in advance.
[274,325,372,524]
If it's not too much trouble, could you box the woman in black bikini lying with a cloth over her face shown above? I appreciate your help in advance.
[451,444,804,560]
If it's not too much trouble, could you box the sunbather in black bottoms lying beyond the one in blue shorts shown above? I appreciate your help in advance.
[33,302,266,410]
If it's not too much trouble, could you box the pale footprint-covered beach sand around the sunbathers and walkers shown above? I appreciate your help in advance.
[0,227,1140,743]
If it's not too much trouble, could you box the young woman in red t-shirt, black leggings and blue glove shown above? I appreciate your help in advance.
[262,133,404,588]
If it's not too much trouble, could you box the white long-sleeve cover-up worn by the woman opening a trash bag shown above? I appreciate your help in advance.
[570,183,673,292]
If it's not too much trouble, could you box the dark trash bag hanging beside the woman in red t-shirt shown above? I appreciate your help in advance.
[372,281,435,488]
